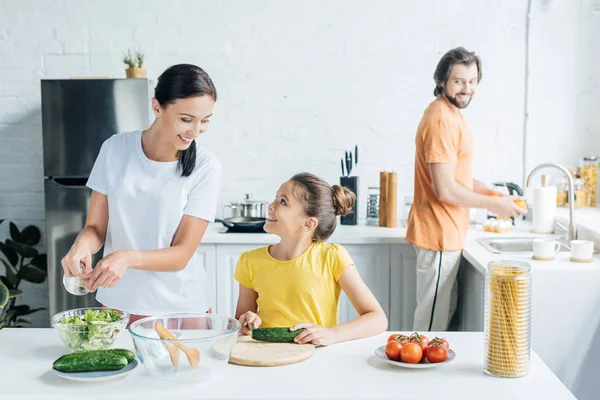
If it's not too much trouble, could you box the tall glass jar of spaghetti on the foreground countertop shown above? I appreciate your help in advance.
[483,261,531,378]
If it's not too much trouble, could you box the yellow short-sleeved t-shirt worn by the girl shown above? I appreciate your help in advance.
[234,242,354,328]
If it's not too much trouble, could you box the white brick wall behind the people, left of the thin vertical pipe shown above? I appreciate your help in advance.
[0,0,600,323]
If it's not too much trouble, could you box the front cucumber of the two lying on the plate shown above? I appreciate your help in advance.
[52,353,129,372]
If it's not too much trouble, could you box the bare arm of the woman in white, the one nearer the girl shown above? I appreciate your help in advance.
[86,215,208,291]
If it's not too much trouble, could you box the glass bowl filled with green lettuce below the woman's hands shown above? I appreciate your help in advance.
[52,307,129,351]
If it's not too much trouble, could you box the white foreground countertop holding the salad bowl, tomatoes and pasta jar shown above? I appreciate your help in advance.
[0,328,575,400]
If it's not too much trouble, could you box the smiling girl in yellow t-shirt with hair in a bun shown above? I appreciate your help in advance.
[234,173,387,346]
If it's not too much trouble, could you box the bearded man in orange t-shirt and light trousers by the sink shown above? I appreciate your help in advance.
[406,47,526,331]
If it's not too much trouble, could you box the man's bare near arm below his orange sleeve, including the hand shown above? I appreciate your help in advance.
[429,163,527,218]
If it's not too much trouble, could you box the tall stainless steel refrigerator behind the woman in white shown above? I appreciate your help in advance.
[41,79,151,316]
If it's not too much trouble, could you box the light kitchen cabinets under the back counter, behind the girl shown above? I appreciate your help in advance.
[198,243,416,331]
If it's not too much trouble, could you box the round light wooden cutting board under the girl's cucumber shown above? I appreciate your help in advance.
[229,335,315,367]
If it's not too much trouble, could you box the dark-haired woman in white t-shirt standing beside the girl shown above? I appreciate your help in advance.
[62,64,221,322]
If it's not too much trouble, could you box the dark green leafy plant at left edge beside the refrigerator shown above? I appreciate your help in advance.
[0,220,47,329]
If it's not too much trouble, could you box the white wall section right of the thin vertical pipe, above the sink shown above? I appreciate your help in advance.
[526,0,600,177]
